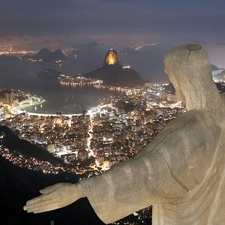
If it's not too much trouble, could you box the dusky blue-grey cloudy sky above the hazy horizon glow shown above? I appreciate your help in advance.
[0,0,225,44]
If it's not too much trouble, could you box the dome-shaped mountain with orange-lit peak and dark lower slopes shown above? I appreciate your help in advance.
[83,49,146,87]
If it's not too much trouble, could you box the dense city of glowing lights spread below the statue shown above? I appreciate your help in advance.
[0,78,185,224]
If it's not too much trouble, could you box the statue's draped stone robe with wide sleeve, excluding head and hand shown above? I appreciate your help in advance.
[81,110,225,225]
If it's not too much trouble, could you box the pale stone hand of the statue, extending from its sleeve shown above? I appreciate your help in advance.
[23,183,86,213]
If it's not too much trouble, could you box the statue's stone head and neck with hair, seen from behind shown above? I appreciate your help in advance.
[164,44,218,110]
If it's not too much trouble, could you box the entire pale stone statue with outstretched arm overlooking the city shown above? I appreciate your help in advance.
[24,45,225,225]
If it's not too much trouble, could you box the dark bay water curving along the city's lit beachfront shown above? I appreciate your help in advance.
[0,61,114,113]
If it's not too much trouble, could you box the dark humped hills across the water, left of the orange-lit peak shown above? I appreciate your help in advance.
[22,48,67,62]
